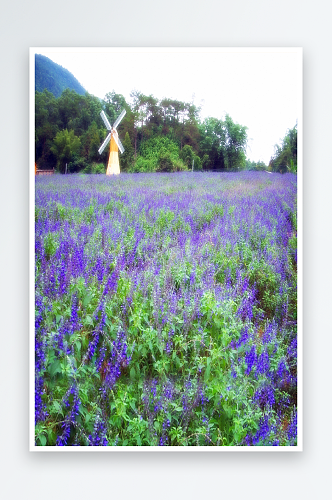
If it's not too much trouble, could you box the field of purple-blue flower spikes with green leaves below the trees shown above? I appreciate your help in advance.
[35,172,297,446]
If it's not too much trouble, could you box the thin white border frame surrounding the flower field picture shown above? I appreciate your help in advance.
[29,47,303,452]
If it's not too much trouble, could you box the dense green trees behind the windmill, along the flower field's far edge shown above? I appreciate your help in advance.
[35,88,297,173]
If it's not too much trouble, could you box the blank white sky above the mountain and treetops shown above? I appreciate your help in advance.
[32,47,302,164]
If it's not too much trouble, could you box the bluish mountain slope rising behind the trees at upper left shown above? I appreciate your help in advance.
[35,54,86,97]
